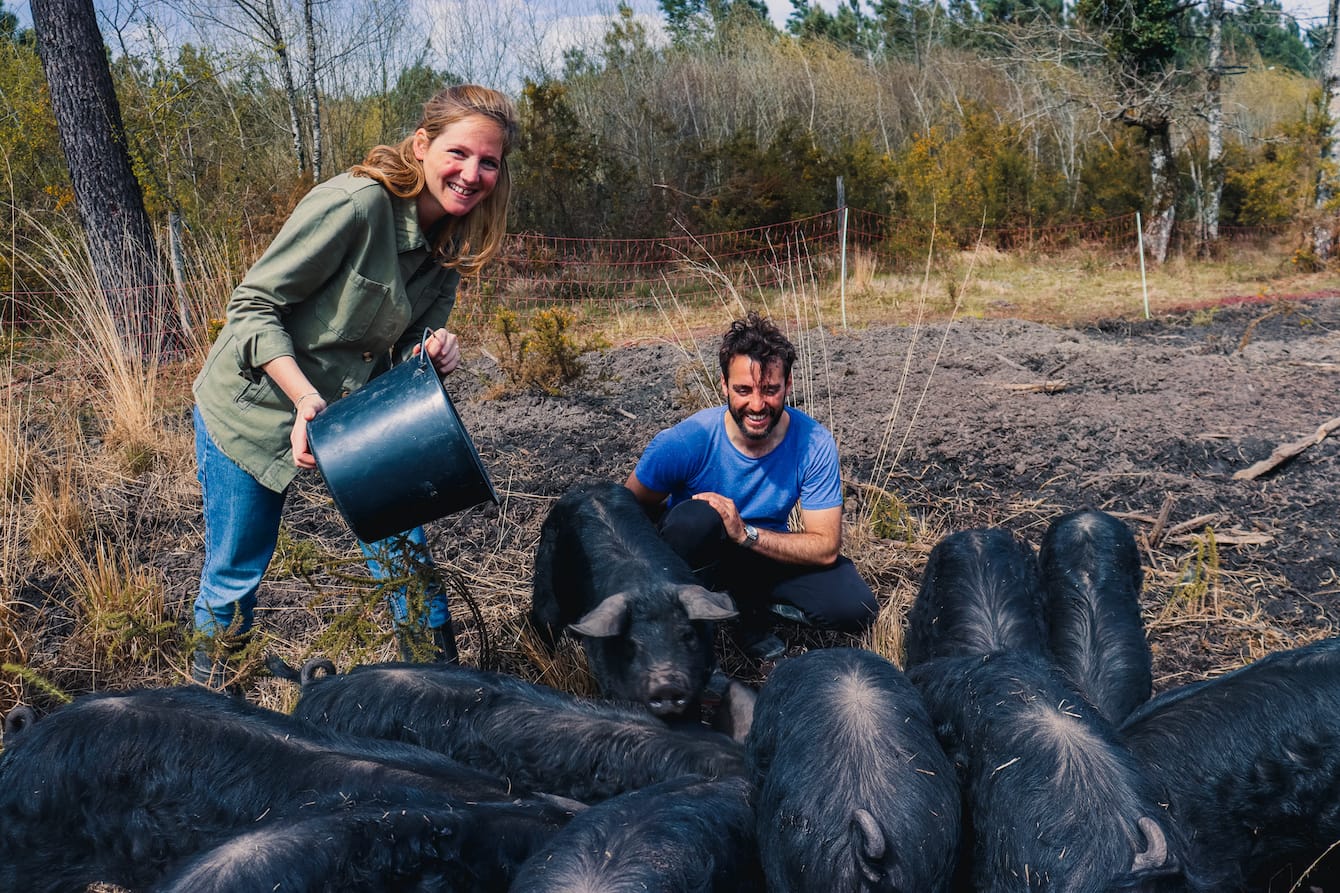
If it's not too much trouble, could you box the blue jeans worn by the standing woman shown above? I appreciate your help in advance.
[193,408,452,636]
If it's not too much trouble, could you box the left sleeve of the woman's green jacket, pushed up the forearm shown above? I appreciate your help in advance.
[226,186,370,370]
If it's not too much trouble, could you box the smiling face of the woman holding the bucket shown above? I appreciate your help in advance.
[414,115,503,228]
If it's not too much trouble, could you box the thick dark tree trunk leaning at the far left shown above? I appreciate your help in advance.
[32,0,161,350]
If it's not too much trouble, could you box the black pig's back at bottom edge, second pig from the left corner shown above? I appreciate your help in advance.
[150,803,553,893]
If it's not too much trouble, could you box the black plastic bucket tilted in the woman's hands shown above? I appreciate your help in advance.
[307,331,498,542]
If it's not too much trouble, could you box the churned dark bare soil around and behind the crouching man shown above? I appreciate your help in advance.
[15,294,1340,709]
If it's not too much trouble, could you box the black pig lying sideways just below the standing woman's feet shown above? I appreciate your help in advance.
[293,664,744,802]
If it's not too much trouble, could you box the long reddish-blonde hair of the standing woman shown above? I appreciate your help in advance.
[351,83,519,276]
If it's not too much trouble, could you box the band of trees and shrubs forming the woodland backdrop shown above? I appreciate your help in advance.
[0,0,1335,305]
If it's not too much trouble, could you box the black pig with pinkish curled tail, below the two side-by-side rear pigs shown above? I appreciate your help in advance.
[909,652,1210,893]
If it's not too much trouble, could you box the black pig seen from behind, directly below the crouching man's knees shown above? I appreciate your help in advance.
[746,648,959,893]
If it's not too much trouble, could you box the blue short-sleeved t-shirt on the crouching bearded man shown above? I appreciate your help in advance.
[634,406,842,531]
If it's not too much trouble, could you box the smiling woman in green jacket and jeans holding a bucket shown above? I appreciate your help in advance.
[192,84,517,687]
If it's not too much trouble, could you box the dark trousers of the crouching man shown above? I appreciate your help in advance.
[661,499,879,633]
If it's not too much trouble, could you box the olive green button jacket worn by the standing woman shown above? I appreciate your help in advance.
[194,173,460,492]
